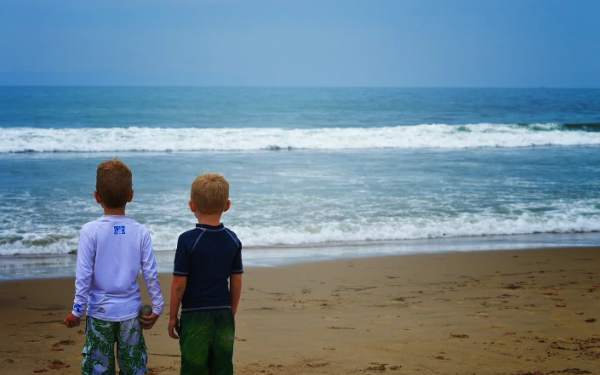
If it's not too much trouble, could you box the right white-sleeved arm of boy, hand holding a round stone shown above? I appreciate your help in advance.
[140,230,164,329]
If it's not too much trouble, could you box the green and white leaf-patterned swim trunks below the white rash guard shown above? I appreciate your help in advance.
[81,316,148,375]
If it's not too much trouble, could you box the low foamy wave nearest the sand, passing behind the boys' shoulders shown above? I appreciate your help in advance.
[0,213,600,255]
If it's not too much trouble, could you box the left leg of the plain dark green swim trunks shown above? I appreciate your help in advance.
[179,310,212,375]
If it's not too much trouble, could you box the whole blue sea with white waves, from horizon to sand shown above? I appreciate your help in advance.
[0,87,600,279]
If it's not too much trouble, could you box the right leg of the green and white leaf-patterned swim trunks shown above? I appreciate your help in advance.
[117,317,148,375]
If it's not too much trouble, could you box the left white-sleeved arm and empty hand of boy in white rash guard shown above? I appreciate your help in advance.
[63,228,95,328]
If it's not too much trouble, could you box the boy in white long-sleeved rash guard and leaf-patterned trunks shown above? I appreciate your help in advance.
[63,159,163,375]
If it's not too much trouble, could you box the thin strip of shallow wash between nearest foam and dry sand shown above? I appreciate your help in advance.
[0,233,600,282]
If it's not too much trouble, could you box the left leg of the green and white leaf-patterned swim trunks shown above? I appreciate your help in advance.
[81,316,117,375]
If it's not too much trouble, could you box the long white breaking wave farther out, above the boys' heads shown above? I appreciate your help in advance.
[0,123,600,153]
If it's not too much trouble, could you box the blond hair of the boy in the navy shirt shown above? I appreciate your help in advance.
[190,173,229,215]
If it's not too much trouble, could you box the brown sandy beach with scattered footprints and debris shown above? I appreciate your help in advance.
[0,248,600,375]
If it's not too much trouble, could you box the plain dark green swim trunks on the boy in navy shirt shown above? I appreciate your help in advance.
[179,309,235,375]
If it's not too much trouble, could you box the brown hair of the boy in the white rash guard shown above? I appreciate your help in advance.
[96,158,132,208]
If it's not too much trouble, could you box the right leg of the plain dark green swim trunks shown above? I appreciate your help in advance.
[209,309,235,375]
